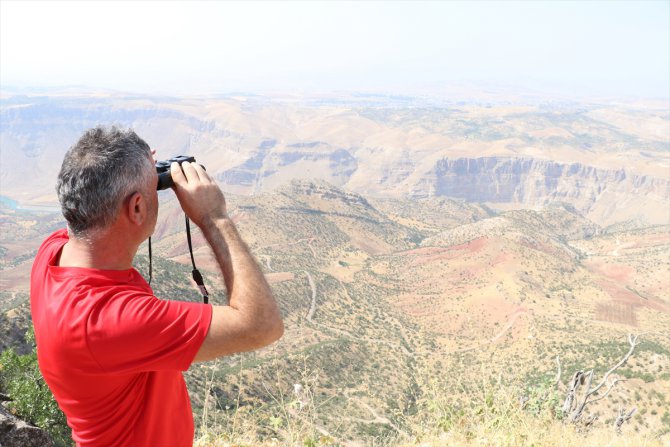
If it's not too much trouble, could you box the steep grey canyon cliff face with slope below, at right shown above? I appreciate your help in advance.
[413,157,670,228]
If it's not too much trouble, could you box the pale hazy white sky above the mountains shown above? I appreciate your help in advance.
[0,0,670,98]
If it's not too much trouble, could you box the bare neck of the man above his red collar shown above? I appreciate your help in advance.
[58,231,138,270]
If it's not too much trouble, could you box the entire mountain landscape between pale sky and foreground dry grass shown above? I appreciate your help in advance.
[0,90,670,444]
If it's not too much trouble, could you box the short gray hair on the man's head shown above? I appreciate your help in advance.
[56,126,153,236]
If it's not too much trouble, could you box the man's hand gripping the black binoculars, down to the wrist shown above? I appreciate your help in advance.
[170,161,227,228]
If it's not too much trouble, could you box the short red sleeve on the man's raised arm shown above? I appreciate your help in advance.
[85,293,212,374]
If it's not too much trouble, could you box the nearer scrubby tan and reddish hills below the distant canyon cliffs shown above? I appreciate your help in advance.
[0,180,670,445]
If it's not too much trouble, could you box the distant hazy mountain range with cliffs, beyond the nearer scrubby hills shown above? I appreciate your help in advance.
[0,92,670,226]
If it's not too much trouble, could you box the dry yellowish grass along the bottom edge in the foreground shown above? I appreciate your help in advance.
[195,370,670,447]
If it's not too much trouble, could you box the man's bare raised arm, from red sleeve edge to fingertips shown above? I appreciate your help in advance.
[170,162,284,362]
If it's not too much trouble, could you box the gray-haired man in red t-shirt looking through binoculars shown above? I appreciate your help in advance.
[30,127,284,446]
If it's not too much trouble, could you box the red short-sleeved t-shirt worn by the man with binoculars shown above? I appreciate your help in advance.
[30,230,212,446]
